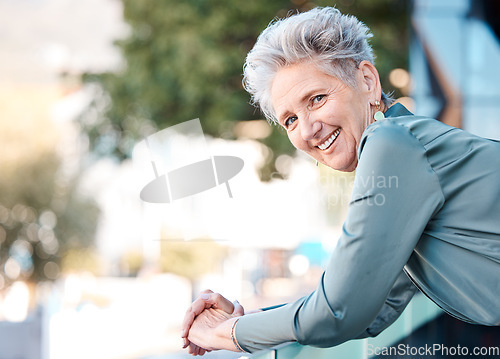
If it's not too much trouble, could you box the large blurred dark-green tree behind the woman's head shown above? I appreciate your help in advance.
[82,0,408,180]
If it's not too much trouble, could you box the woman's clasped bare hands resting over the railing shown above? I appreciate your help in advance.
[181,290,245,355]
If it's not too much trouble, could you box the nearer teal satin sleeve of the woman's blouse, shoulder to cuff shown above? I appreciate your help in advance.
[235,120,444,352]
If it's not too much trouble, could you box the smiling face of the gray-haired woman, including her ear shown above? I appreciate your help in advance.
[271,61,381,172]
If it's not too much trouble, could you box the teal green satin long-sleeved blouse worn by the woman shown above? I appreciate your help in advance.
[235,104,500,352]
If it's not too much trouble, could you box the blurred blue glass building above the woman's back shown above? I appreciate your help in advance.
[410,0,500,139]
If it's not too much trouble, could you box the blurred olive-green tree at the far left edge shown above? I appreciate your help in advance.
[0,134,99,290]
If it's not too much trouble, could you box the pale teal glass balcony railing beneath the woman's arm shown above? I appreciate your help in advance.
[252,294,443,359]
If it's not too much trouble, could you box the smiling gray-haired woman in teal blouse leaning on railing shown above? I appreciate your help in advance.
[182,8,500,355]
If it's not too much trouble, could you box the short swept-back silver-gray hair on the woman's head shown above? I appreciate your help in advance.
[243,7,391,121]
